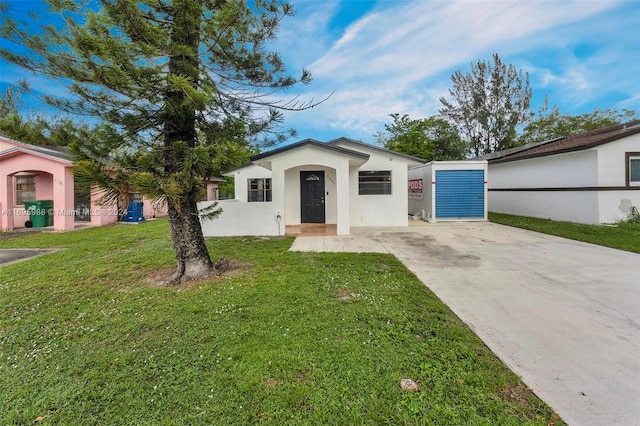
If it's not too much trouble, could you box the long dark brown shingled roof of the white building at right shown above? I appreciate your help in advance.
[481,120,640,164]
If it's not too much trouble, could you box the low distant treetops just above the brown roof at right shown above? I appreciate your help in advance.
[519,106,637,144]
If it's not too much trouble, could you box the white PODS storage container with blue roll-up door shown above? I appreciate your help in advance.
[408,160,487,222]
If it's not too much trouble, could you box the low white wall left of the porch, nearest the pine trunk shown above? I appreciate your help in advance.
[198,200,284,237]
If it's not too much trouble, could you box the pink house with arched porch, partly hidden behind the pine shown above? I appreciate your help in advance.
[0,136,220,231]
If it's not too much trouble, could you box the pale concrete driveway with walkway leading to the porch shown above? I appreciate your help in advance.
[291,221,640,426]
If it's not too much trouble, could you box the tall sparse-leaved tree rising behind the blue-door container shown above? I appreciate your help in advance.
[439,53,534,155]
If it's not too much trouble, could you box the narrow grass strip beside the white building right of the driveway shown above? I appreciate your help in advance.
[489,212,640,253]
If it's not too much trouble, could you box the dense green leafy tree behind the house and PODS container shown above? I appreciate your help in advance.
[376,113,467,161]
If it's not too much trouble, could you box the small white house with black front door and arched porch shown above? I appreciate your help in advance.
[199,138,424,236]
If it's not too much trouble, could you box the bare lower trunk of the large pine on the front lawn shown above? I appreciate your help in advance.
[168,202,213,284]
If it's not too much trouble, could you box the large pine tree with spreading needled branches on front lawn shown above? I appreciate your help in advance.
[0,0,311,283]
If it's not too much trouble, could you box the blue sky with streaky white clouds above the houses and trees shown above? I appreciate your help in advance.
[0,0,640,142]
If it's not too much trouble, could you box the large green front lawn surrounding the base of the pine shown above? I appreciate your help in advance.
[0,220,562,425]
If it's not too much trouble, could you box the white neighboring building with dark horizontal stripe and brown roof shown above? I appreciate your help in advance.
[481,120,640,224]
